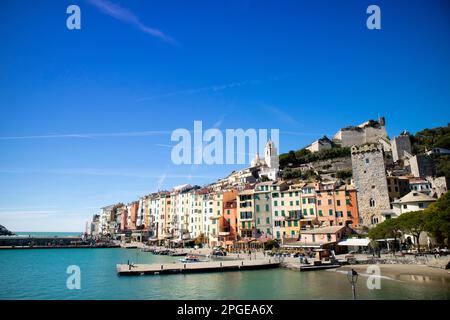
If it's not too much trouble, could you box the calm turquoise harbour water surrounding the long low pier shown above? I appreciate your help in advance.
[0,248,450,300]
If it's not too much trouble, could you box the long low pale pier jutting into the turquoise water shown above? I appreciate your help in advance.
[117,259,280,276]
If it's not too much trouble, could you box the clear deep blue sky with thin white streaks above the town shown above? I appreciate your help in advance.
[0,0,450,231]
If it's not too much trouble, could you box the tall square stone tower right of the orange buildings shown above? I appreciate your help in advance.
[351,144,390,227]
